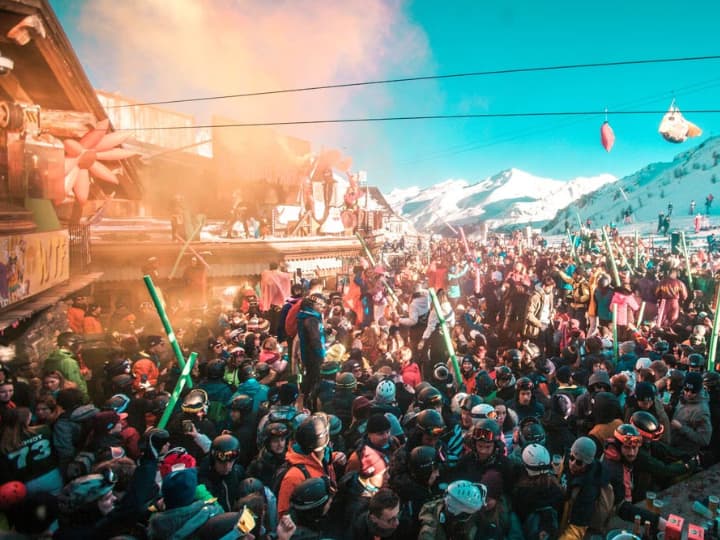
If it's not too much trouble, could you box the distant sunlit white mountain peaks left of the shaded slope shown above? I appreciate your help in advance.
[385,169,617,230]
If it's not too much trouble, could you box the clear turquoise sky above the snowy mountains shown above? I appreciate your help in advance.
[51,0,720,191]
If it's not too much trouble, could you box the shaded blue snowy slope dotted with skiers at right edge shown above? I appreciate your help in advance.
[546,137,720,233]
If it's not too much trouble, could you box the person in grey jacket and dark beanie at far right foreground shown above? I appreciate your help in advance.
[670,372,712,455]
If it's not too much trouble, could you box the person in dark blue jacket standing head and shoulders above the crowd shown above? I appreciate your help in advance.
[297,293,326,403]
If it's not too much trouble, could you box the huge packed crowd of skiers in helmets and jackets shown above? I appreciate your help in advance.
[0,229,720,540]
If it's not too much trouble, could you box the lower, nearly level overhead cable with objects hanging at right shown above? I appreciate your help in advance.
[116,109,720,131]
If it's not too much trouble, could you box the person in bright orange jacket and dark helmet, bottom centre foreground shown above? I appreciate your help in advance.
[278,413,347,516]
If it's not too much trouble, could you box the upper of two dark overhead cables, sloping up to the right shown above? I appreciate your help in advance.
[106,55,720,109]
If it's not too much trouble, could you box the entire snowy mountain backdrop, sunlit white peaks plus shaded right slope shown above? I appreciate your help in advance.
[385,137,720,234]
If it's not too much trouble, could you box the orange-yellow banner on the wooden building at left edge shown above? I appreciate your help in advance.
[0,230,70,308]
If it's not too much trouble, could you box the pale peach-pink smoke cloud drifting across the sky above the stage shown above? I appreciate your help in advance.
[78,0,429,150]
